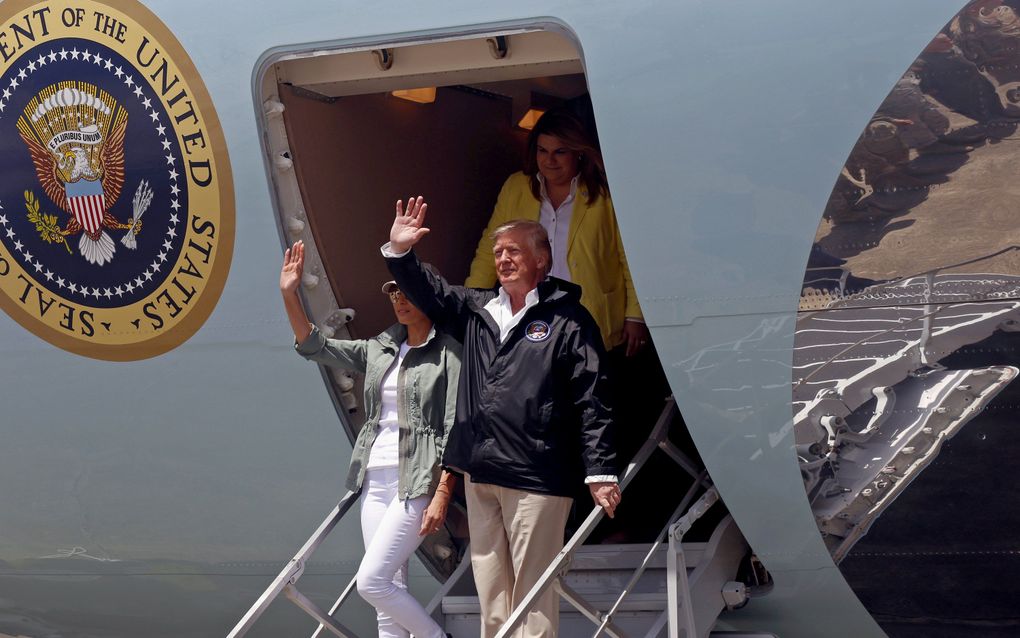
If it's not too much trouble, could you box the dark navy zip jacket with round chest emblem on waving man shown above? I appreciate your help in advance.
[387,251,617,496]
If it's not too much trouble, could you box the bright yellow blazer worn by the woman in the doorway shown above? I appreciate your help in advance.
[464,173,643,348]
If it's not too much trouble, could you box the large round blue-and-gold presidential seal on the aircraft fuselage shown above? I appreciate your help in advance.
[0,0,234,360]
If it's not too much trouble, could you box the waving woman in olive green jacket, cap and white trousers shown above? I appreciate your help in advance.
[279,242,460,638]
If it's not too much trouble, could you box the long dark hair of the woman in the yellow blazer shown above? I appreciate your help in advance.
[524,107,609,204]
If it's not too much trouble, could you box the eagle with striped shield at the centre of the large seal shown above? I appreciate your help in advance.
[17,82,152,265]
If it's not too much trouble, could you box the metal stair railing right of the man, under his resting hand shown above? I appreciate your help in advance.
[496,397,718,638]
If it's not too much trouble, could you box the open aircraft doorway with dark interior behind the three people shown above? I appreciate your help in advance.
[248,23,768,635]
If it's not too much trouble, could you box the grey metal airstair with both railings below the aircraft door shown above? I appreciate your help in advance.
[227,398,772,638]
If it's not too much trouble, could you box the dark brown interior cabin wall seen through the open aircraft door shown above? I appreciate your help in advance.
[279,85,526,338]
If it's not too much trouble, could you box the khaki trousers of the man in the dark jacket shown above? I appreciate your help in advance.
[465,480,573,638]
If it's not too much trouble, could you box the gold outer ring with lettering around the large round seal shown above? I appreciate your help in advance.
[0,0,236,361]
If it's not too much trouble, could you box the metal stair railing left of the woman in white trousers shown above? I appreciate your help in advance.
[226,491,358,638]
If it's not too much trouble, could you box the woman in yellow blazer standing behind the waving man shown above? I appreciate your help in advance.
[464,109,649,356]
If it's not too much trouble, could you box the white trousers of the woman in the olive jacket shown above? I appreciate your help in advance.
[358,468,446,638]
